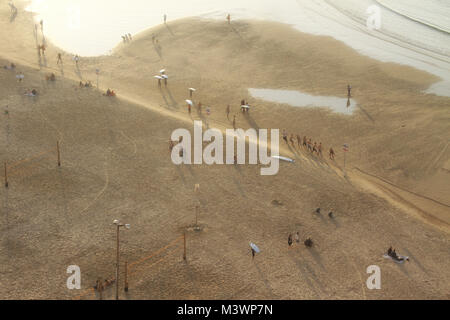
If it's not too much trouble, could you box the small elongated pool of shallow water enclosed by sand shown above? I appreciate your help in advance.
[248,88,356,115]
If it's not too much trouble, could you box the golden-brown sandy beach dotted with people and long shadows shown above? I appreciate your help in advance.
[0,1,450,299]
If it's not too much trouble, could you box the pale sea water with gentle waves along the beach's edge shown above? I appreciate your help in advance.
[29,0,450,96]
